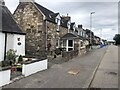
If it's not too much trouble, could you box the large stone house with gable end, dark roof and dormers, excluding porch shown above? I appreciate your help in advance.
[13,0,70,58]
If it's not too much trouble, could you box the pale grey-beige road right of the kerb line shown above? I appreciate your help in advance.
[91,45,118,88]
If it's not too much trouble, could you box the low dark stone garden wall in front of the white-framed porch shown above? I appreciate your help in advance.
[62,50,79,61]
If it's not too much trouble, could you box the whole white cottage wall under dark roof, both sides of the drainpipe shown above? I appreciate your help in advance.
[0,32,25,61]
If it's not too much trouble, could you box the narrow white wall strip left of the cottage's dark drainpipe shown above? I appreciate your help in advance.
[0,32,5,61]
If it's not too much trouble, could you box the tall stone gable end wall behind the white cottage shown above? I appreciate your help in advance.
[14,2,46,58]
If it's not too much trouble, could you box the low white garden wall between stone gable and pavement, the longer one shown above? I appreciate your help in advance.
[22,59,48,76]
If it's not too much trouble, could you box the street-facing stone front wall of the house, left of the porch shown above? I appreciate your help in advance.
[47,22,68,51]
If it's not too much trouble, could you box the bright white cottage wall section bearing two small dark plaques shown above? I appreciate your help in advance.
[14,34,25,56]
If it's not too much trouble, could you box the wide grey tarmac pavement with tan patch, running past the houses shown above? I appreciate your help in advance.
[3,47,109,88]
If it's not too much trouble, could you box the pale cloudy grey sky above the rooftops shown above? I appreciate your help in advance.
[4,0,118,40]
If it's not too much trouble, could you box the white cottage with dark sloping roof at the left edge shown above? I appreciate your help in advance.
[0,1,25,61]
